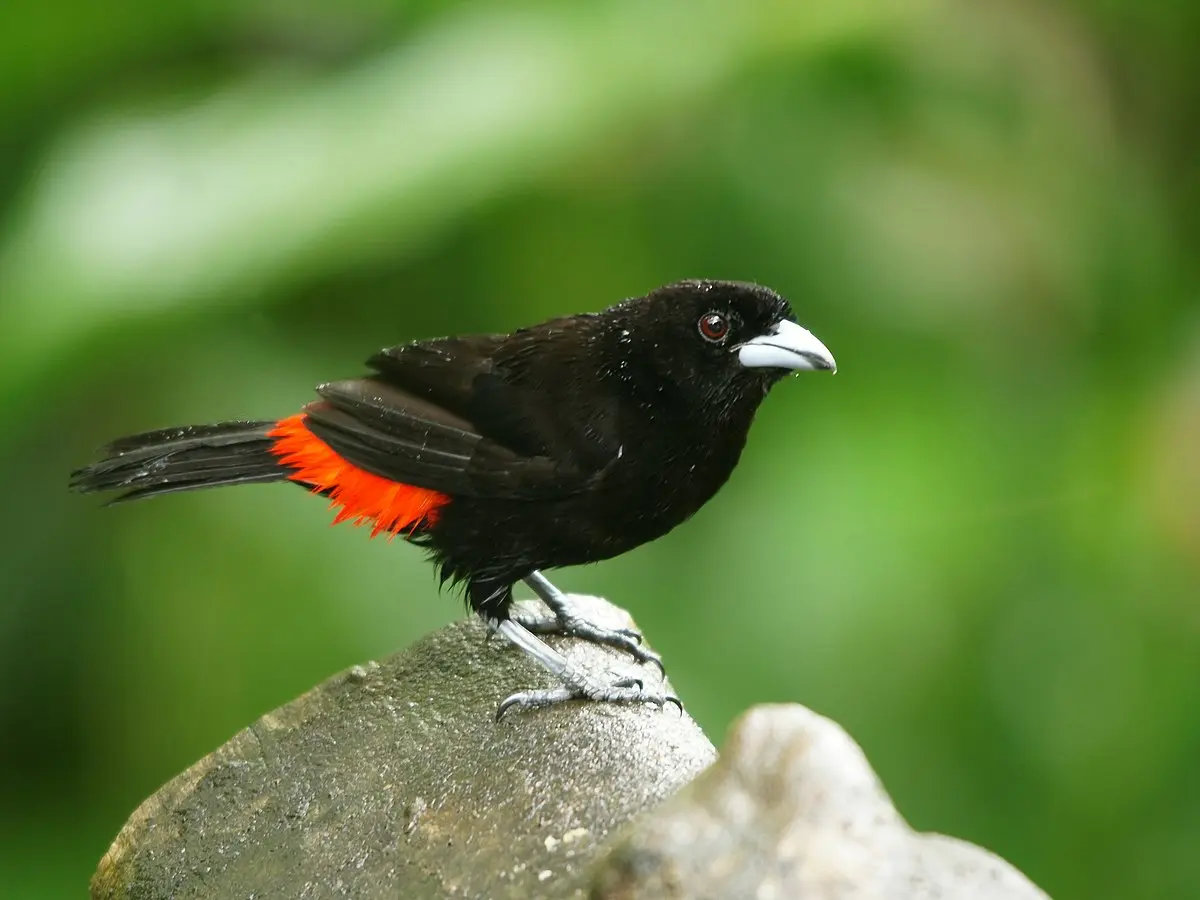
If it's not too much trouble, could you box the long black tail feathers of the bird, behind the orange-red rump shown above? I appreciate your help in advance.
[71,421,292,503]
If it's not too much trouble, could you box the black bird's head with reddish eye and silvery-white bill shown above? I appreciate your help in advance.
[610,280,838,415]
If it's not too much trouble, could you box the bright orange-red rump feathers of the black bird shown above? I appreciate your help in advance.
[268,413,450,538]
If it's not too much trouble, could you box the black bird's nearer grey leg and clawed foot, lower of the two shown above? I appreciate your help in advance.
[487,619,683,721]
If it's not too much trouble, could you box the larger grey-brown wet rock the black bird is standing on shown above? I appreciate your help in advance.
[91,598,715,900]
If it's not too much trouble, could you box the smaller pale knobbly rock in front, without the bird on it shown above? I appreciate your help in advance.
[589,706,1046,900]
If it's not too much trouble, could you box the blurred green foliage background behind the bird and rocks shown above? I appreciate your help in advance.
[0,0,1200,900]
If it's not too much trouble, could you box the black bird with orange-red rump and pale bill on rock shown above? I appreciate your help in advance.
[70,278,836,719]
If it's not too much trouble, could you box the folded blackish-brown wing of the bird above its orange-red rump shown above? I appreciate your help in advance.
[296,336,604,499]
